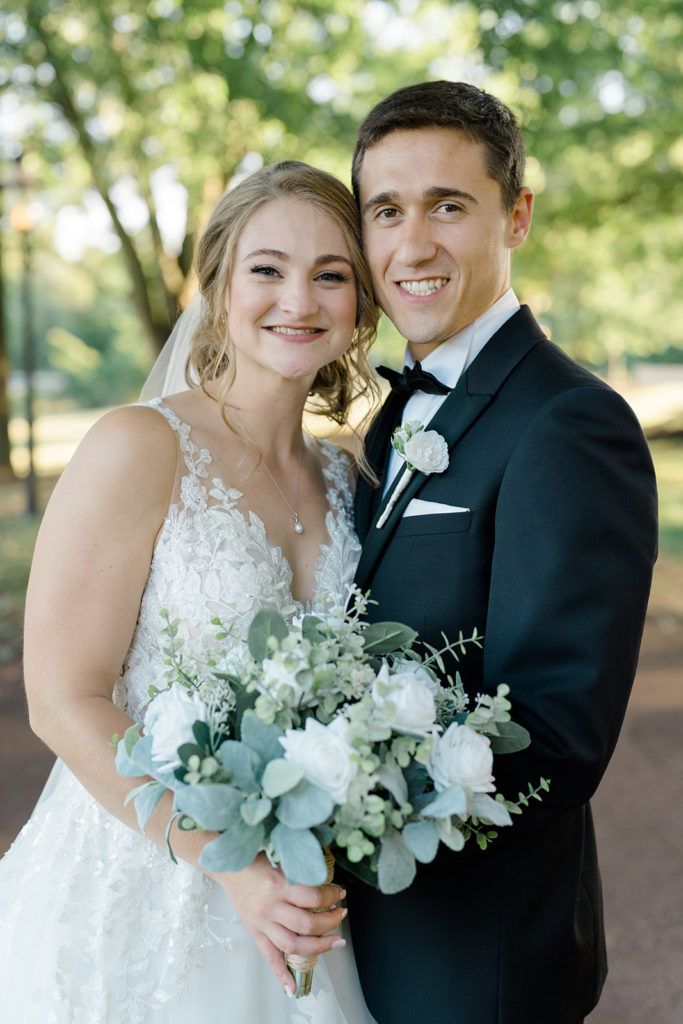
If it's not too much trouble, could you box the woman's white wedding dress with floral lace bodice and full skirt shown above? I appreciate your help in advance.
[0,399,372,1024]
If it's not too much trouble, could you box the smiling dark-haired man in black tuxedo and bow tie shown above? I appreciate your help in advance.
[347,82,656,1024]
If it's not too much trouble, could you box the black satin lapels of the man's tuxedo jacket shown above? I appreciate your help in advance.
[355,306,545,589]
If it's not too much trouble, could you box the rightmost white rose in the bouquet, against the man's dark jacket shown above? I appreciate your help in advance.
[428,722,496,793]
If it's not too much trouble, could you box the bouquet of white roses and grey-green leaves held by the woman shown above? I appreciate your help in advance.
[117,591,548,893]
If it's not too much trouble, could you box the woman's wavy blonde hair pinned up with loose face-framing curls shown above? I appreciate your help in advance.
[187,160,379,429]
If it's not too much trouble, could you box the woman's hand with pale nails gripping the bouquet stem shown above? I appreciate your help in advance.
[212,853,346,993]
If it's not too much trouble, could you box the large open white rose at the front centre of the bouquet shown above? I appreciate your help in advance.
[280,718,358,804]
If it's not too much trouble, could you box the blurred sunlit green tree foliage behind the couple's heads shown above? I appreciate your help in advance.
[0,0,683,382]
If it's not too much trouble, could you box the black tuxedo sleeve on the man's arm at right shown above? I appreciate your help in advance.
[483,387,656,821]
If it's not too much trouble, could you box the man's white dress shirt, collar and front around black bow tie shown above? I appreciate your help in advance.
[384,288,519,494]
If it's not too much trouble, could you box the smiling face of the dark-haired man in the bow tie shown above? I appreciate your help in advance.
[359,128,531,358]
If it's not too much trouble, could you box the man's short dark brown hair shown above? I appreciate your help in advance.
[351,81,526,212]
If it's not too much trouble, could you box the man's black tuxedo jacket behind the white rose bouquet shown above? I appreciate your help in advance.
[347,307,656,1024]
